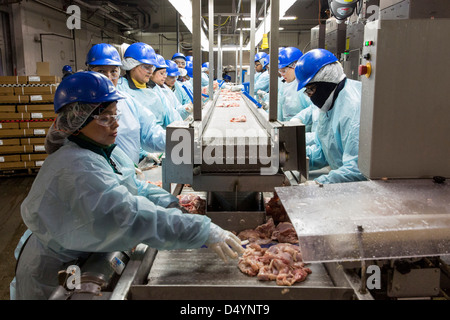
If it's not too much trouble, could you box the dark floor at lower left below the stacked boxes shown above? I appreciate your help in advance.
[0,176,35,300]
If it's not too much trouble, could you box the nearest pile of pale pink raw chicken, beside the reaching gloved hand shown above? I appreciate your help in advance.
[238,243,311,286]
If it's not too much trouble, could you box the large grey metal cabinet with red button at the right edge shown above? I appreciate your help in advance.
[359,19,450,179]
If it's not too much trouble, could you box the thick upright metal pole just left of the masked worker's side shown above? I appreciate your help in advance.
[269,0,280,121]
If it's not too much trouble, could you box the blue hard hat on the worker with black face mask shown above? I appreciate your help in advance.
[295,49,338,90]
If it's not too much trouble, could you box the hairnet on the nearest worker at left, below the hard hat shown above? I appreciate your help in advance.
[45,102,98,154]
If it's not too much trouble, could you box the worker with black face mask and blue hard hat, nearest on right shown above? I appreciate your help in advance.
[295,49,366,183]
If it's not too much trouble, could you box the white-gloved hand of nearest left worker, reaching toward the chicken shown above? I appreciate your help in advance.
[205,222,244,262]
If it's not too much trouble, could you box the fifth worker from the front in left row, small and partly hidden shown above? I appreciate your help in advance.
[164,60,193,120]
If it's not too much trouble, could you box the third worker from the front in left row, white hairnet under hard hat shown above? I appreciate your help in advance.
[117,42,183,129]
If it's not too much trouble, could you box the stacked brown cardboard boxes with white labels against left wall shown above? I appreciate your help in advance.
[0,76,60,174]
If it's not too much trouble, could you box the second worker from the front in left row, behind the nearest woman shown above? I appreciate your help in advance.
[86,43,166,164]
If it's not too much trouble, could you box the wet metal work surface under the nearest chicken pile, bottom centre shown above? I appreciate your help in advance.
[131,248,353,300]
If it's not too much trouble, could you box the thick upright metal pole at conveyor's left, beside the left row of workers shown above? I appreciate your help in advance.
[192,0,202,121]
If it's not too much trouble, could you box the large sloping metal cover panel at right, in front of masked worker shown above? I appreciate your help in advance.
[275,179,450,262]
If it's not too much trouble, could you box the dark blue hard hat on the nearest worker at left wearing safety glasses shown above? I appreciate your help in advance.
[53,71,125,113]
